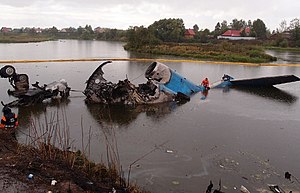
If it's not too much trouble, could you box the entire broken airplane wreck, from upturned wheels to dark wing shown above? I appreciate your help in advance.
[0,61,300,106]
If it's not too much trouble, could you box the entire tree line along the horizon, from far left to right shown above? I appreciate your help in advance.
[2,18,300,49]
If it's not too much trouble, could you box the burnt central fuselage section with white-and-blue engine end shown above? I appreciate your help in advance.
[83,61,204,105]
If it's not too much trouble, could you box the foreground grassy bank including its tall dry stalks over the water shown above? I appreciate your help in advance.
[0,109,145,193]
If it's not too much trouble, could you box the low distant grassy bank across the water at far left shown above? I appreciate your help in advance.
[0,33,54,43]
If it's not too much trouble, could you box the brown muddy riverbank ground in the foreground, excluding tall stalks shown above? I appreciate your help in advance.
[0,130,142,193]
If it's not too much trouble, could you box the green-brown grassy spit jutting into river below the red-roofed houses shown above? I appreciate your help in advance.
[125,41,276,63]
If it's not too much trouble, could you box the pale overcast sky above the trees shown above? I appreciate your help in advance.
[0,0,300,31]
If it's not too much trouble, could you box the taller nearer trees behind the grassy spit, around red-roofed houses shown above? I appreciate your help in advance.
[127,18,300,49]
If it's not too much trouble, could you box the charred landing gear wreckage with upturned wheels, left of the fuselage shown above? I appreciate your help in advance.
[0,65,71,106]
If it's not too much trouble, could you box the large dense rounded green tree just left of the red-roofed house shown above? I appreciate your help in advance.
[148,19,185,42]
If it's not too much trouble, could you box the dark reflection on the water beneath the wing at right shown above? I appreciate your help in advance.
[234,87,298,105]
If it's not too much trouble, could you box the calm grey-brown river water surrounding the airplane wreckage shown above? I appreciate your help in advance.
[0,40,300,193]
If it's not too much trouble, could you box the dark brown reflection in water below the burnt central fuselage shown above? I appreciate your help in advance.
[87,102,178,126]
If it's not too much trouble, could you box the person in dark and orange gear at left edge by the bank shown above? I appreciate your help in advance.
[0,106,19,129]
